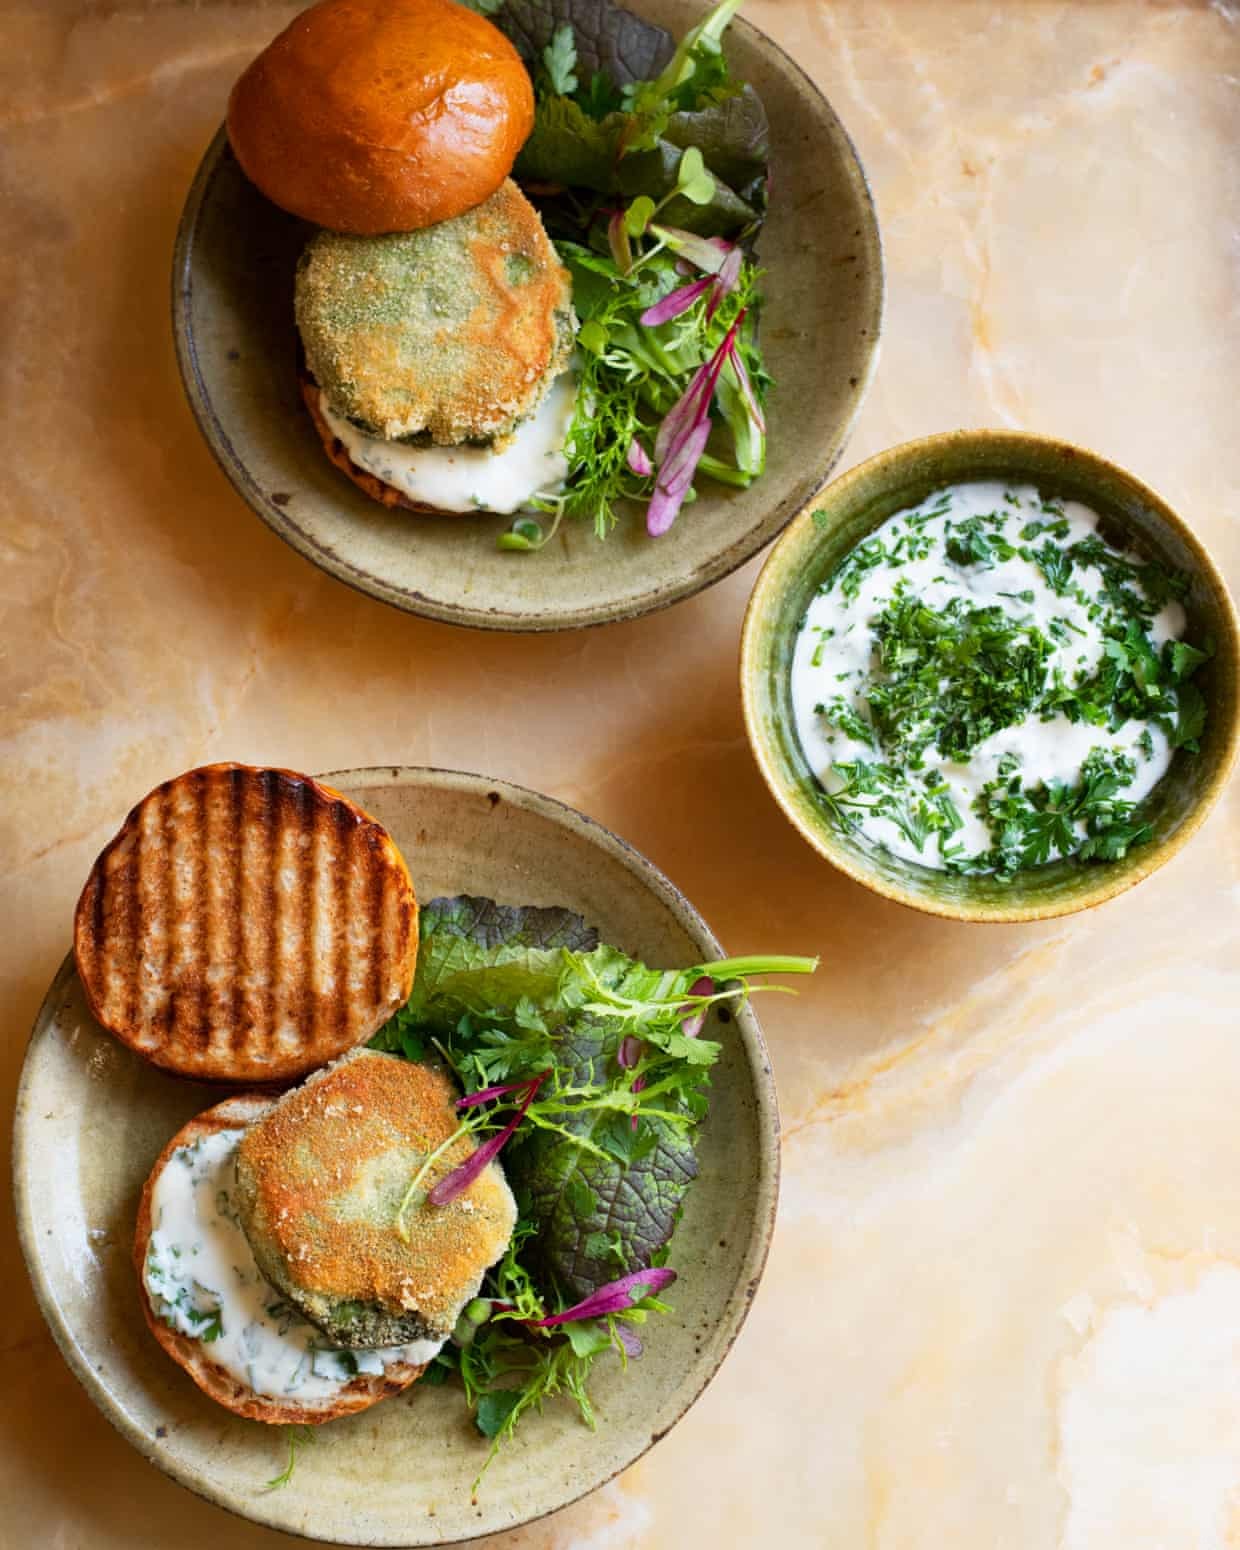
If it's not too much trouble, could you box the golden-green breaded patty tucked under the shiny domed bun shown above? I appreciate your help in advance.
[296,180,575,446]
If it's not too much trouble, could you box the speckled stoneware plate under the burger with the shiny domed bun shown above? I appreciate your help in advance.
[172,0,882,629]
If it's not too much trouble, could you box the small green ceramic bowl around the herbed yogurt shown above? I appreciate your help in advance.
[741,431,1240,921]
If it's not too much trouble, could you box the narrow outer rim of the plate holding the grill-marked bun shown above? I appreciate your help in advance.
[11,764,781,1550]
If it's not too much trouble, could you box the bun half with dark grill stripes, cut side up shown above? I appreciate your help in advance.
[73,764,417,1083]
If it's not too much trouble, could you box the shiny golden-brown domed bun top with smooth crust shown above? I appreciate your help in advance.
[228,0,533,236]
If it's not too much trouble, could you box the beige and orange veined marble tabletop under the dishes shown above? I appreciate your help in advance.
[0,0,1240,1550]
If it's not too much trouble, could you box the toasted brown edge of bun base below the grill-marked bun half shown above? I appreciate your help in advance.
[133,1093,425,1426]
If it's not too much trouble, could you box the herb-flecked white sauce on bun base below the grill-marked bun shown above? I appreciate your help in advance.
[143,1130,443,1400]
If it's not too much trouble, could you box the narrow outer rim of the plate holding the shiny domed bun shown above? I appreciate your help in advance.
[171,16,887,634]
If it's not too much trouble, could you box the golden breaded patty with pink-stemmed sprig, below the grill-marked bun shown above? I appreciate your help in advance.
[237,1049,516,1347]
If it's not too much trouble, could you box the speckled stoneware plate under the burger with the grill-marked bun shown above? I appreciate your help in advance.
[14,769,780,1545]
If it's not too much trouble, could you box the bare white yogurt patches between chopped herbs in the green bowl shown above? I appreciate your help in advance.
[792,482,1186,870]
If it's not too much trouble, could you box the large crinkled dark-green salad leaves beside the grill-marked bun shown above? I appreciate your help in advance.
[372,897,719,1302]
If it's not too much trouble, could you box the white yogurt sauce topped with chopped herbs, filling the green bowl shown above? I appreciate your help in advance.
[792,482,1207,876]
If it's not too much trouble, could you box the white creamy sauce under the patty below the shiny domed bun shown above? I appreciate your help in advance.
[319,370,577,515]
